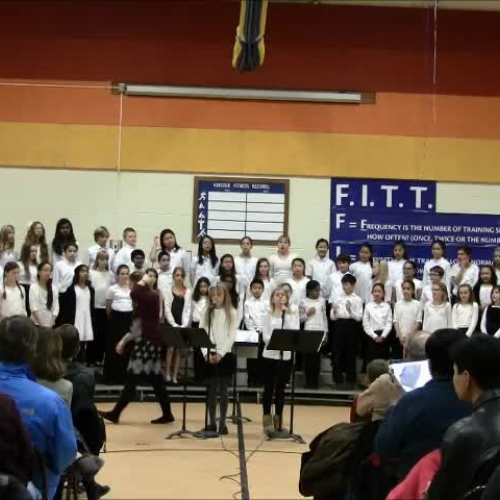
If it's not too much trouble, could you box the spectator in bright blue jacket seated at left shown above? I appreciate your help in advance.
[0,316,76,499]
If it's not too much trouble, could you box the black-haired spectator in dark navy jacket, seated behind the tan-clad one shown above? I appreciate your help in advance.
[374,328,472,481]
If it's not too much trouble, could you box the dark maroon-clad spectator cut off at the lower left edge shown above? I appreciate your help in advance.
[0,393,35,486]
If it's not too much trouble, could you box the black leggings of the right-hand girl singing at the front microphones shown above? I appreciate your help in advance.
[262,358,292,416]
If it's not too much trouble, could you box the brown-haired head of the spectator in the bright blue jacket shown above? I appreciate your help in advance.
[0,316,37,364]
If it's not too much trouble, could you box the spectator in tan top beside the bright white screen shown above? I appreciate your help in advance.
[356,359,404,422]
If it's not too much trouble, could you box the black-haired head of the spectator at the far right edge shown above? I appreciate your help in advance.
[452,335,500,391]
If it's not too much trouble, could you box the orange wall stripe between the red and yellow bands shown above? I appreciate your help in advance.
[0,86,500,139]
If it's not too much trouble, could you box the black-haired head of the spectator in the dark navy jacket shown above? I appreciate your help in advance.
[425,328,464,379]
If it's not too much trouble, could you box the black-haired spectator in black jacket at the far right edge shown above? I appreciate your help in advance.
[428,335,500,500]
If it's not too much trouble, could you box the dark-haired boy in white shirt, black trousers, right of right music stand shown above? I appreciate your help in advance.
[330,273,363,388]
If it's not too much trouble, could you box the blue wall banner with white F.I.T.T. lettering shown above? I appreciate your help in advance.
[330,179,500,271]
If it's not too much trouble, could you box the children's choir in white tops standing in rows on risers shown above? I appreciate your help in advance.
[0,219,500,434]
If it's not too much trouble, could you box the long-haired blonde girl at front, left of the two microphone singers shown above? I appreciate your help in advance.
[200,285,237,436]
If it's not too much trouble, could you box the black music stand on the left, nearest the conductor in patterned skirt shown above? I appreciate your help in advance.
[162,326,213,439]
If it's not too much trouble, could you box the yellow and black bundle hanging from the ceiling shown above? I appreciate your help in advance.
[233,0,268,71]
